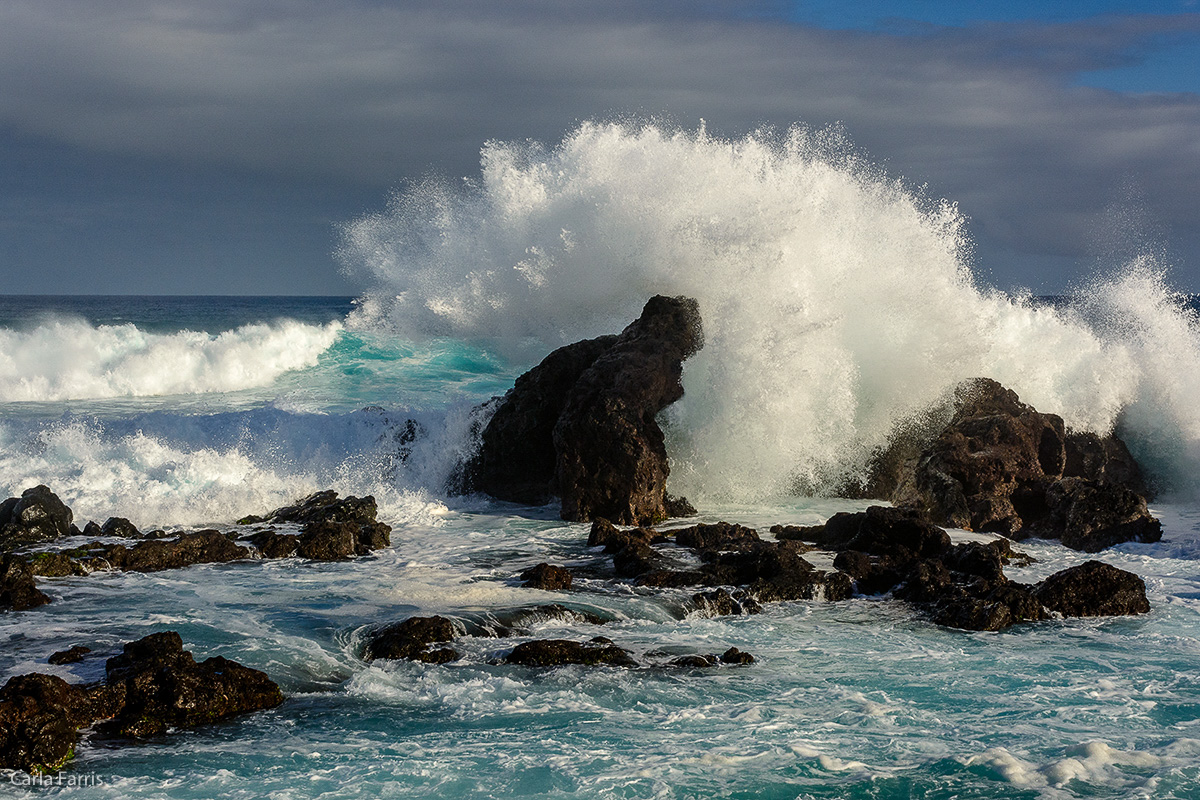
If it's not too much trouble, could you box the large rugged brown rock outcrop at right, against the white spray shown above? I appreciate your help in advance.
[888,378,1162,552]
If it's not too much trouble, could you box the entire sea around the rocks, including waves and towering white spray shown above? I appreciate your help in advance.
[0,124,1200,800]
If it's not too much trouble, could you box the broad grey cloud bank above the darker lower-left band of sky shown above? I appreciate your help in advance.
[0,0,1200,291]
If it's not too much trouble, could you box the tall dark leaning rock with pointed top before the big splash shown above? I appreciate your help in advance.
[467,295,703,524]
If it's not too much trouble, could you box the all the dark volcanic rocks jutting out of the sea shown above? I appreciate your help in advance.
[0,296,1162,772]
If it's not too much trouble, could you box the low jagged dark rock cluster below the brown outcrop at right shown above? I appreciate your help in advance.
[576,506,1150,631]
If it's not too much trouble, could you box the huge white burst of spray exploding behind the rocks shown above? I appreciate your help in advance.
[341,122,1200,501]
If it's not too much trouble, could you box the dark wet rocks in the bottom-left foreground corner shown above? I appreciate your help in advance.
[0,631,283,774]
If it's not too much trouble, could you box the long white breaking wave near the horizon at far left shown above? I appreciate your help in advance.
[0,319,342,402]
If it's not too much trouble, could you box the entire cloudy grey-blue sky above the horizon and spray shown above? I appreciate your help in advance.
[0,0,1200,295]
